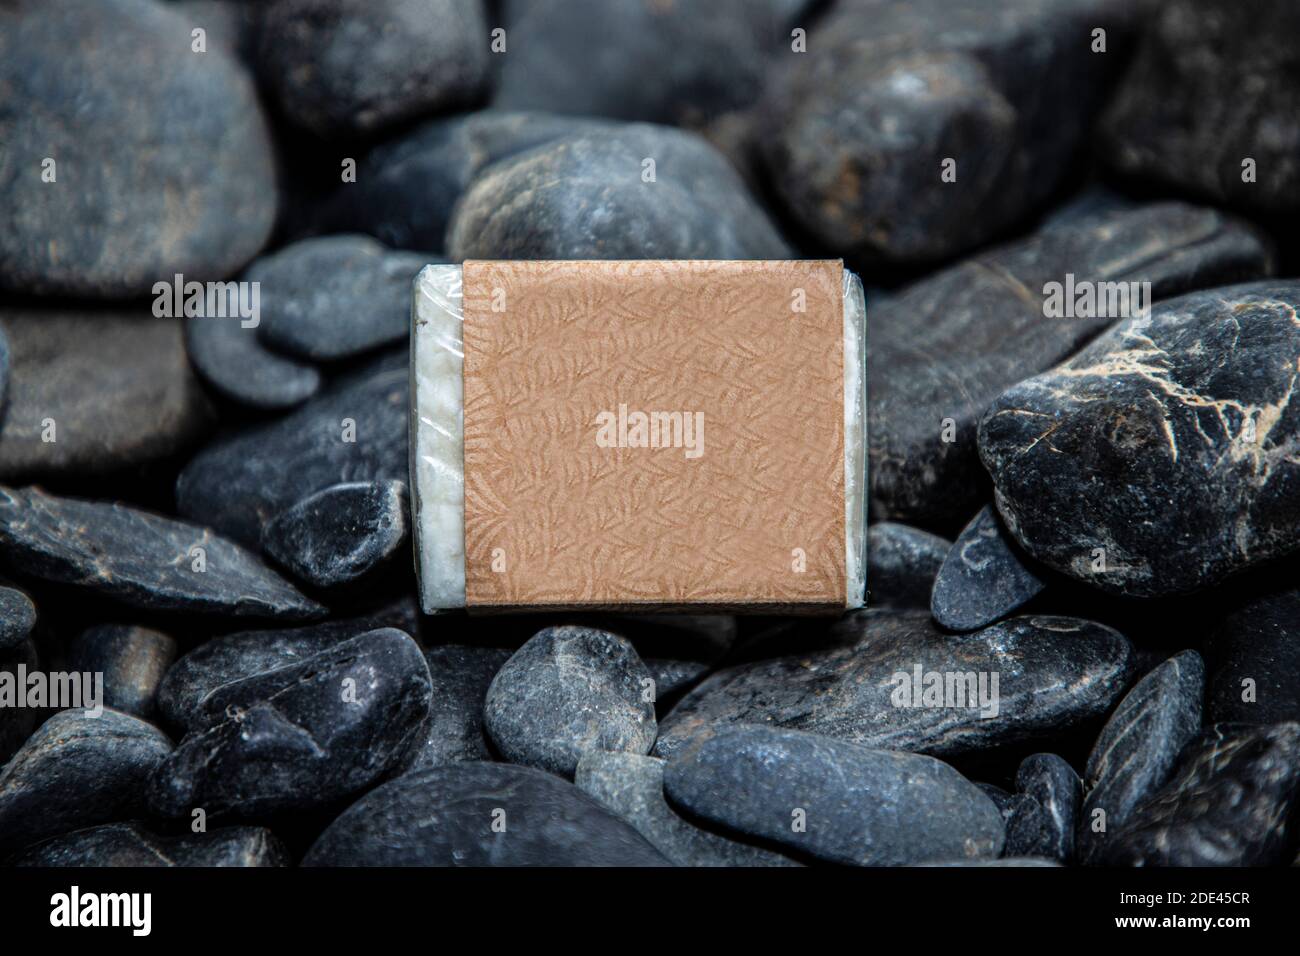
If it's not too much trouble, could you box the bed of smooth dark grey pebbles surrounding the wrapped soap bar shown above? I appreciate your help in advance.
[0,0,1300,866]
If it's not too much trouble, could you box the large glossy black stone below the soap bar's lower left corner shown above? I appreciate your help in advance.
[150,628,430,819]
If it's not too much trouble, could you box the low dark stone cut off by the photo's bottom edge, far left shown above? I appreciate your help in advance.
[8,823,290,868]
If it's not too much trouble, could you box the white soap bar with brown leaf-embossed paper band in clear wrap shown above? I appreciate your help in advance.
[411,260,866,614]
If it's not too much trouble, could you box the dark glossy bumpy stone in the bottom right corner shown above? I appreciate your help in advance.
[1101,723,1300,866]
